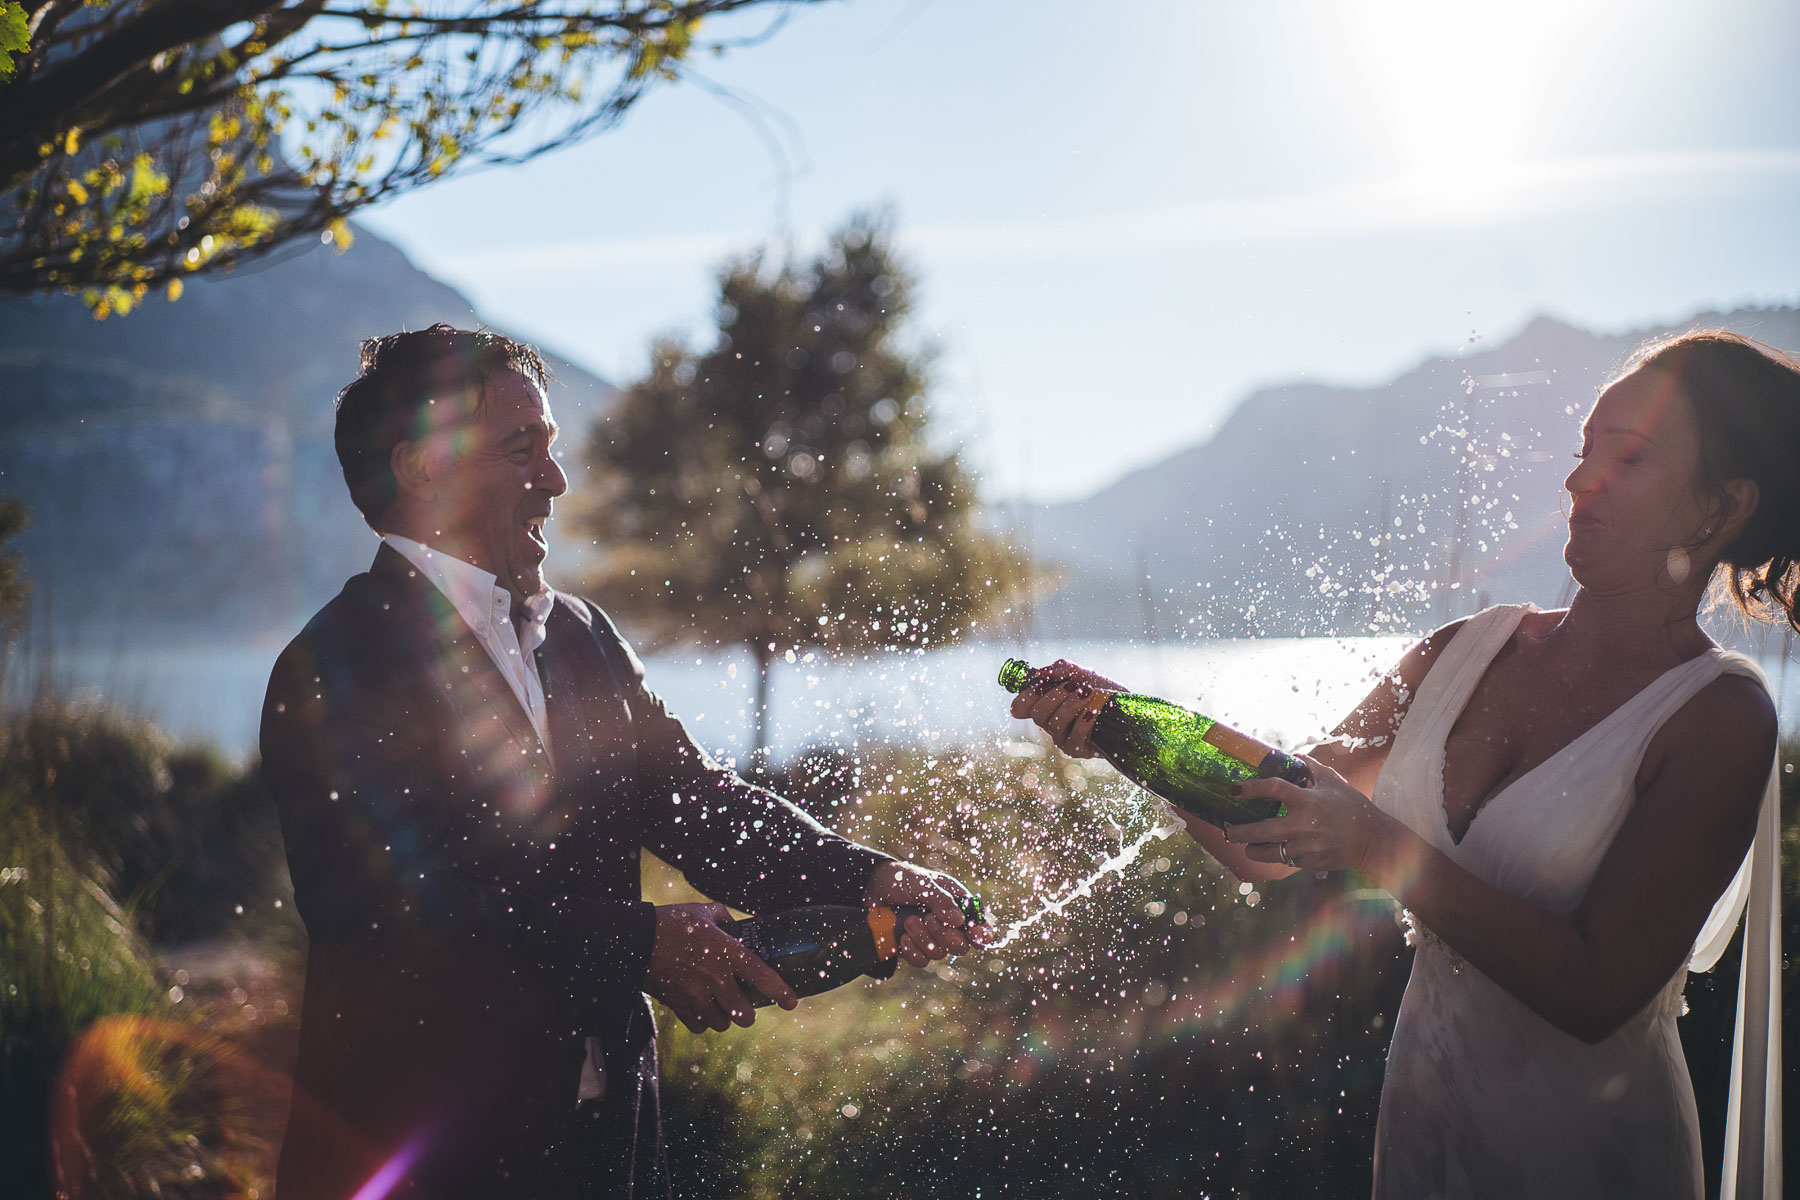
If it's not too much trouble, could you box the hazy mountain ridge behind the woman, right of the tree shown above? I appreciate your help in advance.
[1026,308,1800,637]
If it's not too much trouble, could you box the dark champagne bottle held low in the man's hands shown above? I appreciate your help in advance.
[720,898,981,1007]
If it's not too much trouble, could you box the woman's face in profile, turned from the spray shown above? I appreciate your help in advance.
[1562,369,1710,592]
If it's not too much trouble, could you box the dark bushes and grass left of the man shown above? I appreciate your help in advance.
[0,702,299,1198]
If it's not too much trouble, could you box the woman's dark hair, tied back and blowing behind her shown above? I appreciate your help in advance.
[1625,329,1800,630]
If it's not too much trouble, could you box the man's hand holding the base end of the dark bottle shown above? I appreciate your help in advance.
[644,905,799,1033]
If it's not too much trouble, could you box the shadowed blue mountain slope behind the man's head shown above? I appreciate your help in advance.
[0,228,614,640]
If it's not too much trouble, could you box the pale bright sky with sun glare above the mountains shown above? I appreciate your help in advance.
[364,0,1800,502]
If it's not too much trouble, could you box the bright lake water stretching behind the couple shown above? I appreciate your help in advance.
[5,637,1800,761]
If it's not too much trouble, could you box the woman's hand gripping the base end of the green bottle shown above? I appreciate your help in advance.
[1226,754,1400,873]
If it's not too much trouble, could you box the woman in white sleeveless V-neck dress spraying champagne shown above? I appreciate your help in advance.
[1013,333,1800,1200]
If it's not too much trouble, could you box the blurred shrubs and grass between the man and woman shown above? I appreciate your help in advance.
[662,743,1800,1200]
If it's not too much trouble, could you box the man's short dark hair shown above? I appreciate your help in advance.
[335,324,549,533]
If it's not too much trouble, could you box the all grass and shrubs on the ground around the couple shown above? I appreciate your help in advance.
[0,690,1800,1200]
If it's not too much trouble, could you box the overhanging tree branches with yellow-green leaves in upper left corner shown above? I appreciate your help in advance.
[0,0,824,317]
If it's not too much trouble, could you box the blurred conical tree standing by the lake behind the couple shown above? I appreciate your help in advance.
[583,218,1022,759]
